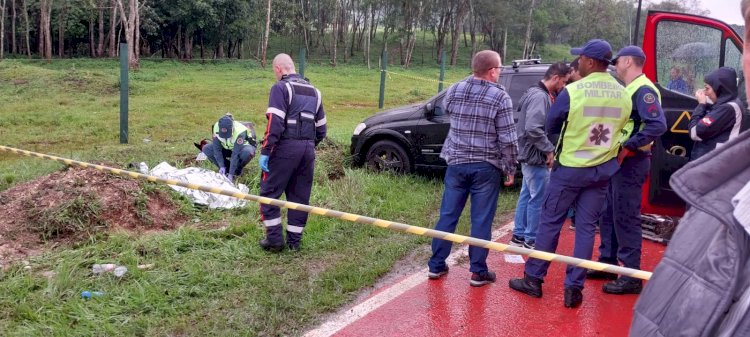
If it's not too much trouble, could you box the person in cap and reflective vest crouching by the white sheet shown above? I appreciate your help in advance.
[202,114,256,182]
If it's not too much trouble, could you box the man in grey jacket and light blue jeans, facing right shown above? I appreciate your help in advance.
[510,63,571,249]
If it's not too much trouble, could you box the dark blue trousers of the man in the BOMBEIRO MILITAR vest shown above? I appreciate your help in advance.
[525,159,618,289]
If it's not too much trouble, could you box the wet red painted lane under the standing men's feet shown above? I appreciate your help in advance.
[328,224,666,337]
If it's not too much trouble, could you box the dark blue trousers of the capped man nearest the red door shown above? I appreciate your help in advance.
[599,153,651,276]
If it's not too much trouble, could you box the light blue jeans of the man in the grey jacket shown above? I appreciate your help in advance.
[513,164,549,242]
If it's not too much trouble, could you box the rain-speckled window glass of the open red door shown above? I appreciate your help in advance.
[656,21,723,96]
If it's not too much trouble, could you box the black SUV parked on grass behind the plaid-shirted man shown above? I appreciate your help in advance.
[351,59,550,173]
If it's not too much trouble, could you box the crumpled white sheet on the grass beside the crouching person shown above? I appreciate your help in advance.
[140,162,250,209]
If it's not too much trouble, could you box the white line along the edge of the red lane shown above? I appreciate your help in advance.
[304,222,513,337]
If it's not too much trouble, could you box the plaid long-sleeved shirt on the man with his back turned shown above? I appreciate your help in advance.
[440,76,518,175]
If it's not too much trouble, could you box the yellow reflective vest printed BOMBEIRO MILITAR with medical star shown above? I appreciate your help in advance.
[557,72,633,167]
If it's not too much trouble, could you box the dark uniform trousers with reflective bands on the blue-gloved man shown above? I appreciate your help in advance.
[260,139,315,245]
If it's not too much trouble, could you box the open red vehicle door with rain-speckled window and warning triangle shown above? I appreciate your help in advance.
[642,11,747,216]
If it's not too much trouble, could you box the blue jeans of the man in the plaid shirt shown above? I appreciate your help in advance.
[427,162,502,273]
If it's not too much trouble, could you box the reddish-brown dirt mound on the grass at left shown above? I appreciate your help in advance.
[0,168,186,265]
